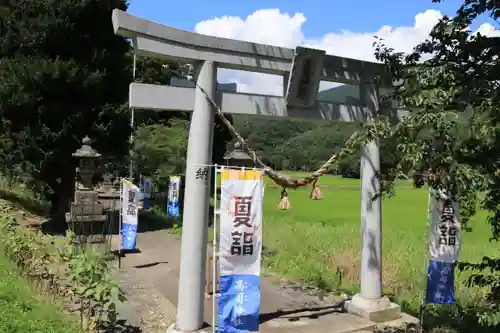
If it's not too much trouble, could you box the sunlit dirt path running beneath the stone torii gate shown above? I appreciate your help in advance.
[113,230,382,333]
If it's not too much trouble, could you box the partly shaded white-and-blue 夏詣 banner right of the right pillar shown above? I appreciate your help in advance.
[426,191,460,304]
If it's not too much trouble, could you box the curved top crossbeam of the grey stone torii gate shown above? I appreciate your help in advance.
[113,9,383,84]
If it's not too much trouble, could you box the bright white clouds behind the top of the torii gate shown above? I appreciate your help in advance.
[195,9,500,95]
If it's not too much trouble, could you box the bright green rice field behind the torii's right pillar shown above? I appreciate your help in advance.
[212,173,500,305]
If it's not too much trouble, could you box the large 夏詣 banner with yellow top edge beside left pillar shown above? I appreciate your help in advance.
[218,169,264,333]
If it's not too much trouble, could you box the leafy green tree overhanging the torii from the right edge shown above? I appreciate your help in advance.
[370,0,500,326]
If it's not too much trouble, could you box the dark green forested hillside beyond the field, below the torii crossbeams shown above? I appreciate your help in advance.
[135,107,395,183]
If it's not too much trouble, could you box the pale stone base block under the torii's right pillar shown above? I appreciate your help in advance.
[346,294,401,323]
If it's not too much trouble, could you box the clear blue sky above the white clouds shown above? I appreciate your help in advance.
[129,0,476,38]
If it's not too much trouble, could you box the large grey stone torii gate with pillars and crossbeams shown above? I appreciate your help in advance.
[112,9,400,332]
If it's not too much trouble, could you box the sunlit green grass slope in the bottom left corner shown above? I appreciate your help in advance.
[0,248,81,333]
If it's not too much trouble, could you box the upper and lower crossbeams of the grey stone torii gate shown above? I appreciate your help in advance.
[112,9,401,121]
